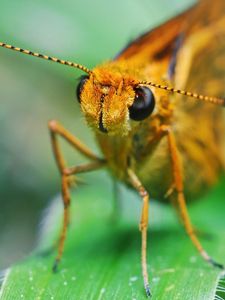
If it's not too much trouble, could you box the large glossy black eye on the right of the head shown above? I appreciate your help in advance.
[129,86,155,121]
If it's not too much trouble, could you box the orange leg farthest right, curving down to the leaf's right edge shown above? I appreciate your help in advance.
[166,128,224,269]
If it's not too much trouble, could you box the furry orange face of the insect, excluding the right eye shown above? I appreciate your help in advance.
[78,63,138,135]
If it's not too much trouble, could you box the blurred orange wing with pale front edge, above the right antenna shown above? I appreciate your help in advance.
[175,0,225,97]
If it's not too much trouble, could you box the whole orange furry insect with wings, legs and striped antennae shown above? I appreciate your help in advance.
[0,0,225,296]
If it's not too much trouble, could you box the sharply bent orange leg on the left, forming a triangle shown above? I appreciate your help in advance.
[49,120,106,271]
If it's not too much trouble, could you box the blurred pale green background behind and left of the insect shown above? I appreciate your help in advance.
[0,0,197,269]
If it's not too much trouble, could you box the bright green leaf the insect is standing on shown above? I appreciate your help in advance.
[0,173,225,300]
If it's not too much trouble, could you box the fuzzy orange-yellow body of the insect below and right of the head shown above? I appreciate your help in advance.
[96,62,225,201]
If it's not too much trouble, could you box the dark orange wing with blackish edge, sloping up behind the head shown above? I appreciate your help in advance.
[116,0,225,83]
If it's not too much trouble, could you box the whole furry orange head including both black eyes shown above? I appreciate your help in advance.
[78,62,160,135]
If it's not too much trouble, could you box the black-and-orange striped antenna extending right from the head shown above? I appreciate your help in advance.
[139,81,225,106]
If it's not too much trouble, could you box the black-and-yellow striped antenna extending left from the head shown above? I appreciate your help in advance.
[0,42,92,74]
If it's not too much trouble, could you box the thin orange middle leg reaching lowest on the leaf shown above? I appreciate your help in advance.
[128,168,151,297]
